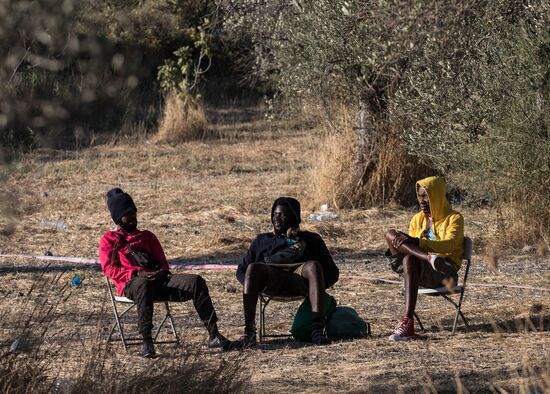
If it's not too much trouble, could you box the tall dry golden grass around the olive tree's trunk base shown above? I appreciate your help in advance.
[311,104,433,208]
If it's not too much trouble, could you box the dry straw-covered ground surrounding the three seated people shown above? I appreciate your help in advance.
[0,110,550,392]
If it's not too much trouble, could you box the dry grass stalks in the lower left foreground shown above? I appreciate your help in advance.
[0,272,249,393]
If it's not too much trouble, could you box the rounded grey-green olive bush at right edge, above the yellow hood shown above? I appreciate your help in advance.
[390,1,550,232]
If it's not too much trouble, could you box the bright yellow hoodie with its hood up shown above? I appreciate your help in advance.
[409,176,464,270]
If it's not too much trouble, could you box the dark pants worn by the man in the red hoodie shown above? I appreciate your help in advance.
[124,274,218,338]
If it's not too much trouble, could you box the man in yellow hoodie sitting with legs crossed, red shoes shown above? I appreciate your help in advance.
[386,176,464,341]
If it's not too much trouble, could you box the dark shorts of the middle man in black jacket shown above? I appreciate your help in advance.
[262,264,309,297]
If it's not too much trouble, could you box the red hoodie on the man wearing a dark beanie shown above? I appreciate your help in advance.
[99,229,169,295]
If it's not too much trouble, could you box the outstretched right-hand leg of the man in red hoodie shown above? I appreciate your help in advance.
[155,274,225,347]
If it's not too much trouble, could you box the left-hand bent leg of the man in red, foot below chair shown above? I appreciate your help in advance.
[124,277,158,357]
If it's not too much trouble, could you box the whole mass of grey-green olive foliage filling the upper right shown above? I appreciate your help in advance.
[226,0,550,237]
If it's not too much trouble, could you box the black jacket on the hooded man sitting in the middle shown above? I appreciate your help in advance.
[237,231,340,288]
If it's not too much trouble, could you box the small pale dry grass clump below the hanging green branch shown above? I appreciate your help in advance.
[153,93,208,143]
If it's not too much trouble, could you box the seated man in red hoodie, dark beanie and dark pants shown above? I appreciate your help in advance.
[99,188,227,358]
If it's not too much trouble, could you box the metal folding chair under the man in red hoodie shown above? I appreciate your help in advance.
[105,277,180,351]
